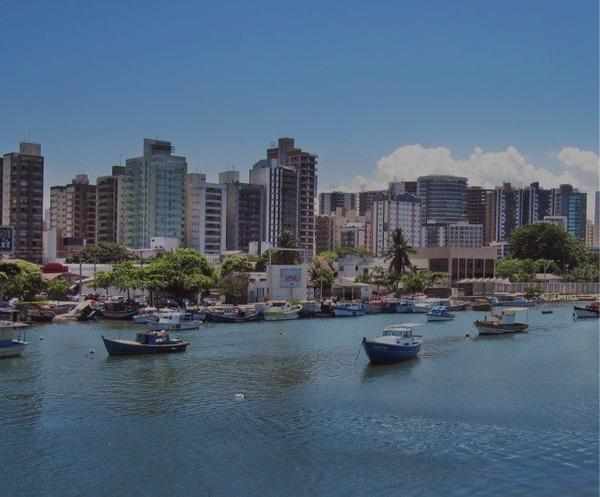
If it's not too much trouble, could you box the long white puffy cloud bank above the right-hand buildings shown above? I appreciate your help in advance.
[336,144,599,196]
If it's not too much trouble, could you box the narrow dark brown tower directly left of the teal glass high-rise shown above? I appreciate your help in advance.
[96,166,125,243]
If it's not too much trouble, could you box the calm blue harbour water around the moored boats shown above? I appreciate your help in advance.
[0,307,598,497]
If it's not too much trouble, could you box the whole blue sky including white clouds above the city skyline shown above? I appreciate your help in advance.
[0,0,599,207]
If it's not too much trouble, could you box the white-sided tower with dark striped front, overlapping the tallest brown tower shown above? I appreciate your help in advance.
[250,159,298,246]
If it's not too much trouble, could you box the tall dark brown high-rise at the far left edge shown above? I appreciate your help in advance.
[0,143,44,263]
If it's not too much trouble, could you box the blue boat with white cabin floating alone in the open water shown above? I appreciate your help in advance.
[362,323,423,364]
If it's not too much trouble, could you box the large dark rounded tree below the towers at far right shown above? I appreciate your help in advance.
[508,223,589,268]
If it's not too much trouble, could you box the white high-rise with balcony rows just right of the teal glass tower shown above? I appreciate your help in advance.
[185,173,227,256]
